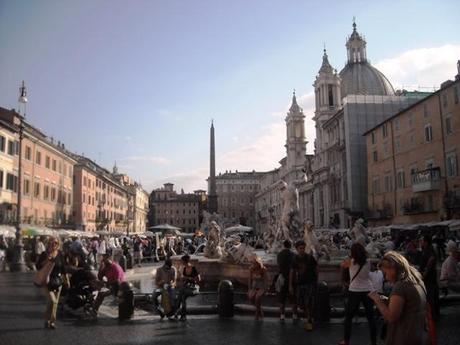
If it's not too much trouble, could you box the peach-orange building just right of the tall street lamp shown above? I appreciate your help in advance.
[0,108,76,227]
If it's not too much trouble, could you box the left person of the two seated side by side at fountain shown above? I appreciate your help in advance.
[153,257,177,319]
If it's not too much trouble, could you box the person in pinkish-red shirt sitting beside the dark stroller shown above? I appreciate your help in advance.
[94,254,125,311]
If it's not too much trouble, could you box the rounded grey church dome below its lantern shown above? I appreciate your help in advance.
[340,61,395,97]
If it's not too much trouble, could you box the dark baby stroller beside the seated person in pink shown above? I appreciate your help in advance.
[67,268,97,318]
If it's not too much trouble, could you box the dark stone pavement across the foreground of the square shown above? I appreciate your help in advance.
[0,273,460,345]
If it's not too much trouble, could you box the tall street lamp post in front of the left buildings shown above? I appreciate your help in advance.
[10,81,27,272]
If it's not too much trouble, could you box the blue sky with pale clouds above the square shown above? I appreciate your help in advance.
[0,0,460,192]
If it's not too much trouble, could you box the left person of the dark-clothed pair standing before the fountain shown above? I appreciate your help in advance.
[275,240,297,321]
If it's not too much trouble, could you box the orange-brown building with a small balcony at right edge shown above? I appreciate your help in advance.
[365,62,460,224]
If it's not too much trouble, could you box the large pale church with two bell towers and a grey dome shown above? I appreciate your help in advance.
[255,23,427,232]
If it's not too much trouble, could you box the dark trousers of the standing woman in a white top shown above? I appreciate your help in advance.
[344,291,377,345]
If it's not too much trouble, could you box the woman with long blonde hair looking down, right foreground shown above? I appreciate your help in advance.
[369,251,428,345]
